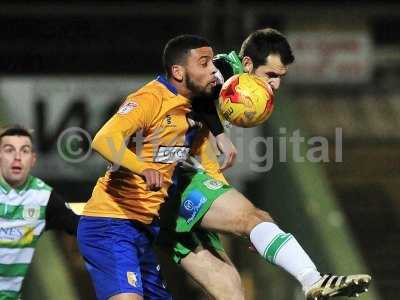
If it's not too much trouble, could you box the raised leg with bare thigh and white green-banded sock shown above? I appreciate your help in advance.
[201,189,321,290]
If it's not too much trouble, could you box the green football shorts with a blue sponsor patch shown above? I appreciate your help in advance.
[158,171,232,263]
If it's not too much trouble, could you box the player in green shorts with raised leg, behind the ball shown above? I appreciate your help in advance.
[160,28,371,300]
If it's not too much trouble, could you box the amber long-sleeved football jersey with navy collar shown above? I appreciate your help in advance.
[83,76,222,224]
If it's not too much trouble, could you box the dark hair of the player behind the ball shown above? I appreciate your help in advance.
[239,28,294,68]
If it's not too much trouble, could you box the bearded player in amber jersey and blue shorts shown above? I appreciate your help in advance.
[78,35,221,300]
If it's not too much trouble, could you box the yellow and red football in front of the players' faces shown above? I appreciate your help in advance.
[218,73,274,127]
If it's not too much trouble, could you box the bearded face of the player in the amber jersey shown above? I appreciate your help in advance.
[185,47,217,97]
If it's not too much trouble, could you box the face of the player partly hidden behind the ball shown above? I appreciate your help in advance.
[250,54,288,90]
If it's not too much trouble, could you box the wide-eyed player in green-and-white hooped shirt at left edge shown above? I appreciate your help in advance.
[0,125,79,300]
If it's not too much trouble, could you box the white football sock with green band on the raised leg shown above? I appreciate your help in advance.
[250,222,321,290]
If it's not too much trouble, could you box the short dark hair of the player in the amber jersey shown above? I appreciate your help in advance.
[162,34,210,77]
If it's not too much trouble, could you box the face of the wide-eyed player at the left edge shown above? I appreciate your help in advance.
[0,136,36,188]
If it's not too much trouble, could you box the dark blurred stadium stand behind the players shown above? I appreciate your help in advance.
[0,0,400,300]
